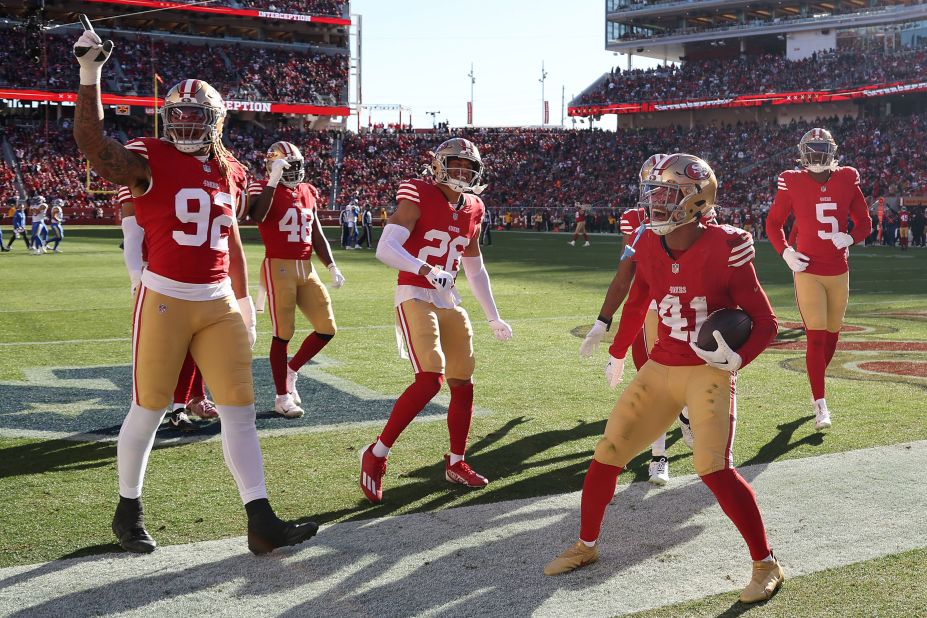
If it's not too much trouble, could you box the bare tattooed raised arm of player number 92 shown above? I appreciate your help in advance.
[74,86,151,187]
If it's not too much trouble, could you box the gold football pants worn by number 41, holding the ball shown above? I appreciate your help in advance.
[595,360,737,476]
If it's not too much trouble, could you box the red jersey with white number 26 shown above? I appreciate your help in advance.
[396,180,485,289]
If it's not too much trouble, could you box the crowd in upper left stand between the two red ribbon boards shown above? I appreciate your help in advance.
[0,29,349,105]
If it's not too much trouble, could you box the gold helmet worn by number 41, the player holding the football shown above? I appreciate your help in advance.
[639,153,718,236]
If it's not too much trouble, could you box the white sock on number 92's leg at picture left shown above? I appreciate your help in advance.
[116,403,164,498]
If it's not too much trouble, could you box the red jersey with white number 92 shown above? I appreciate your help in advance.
[126,137,246,284]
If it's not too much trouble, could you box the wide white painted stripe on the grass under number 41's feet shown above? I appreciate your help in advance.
[0,441,927,618]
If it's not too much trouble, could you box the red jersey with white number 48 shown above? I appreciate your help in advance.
[248,180,319,260]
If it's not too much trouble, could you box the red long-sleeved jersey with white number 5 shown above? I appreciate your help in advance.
[766,167,872,275]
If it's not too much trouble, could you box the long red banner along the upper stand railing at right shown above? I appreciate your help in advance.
[568,81,927,116]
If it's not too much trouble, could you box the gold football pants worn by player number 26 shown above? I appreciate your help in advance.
[396,299,476,380]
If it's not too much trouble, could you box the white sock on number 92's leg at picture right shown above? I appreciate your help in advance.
[216,404,267,504]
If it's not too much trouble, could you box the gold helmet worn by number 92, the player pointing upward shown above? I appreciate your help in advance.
[161,79,225,153]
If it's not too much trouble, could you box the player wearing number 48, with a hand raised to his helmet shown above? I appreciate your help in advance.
[248,142,344,418]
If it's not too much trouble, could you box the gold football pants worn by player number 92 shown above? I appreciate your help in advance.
[132,286,254,410]
